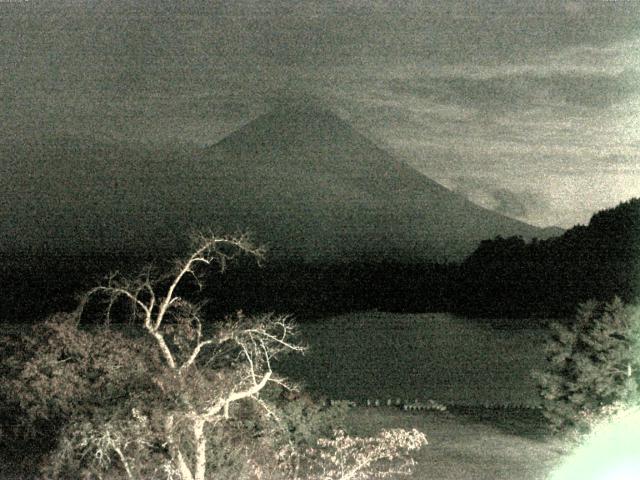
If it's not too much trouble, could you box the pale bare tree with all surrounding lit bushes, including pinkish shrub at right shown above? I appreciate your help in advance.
[6,234,426,480]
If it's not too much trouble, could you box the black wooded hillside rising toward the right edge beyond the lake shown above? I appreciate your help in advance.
[454,199,640,317]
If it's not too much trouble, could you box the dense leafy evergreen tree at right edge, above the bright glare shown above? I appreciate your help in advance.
[535,298,640,431]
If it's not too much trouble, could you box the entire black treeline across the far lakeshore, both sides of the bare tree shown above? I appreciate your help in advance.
[0,199,640,322]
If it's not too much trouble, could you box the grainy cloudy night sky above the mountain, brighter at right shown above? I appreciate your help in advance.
[0,0,640,228]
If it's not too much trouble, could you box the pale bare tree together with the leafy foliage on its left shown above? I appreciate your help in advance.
[9,234,304,480]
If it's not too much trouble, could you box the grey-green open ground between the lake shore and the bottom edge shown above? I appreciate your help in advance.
[0,407,565,480]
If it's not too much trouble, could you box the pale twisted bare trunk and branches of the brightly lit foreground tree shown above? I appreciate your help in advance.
[87,231,303,480]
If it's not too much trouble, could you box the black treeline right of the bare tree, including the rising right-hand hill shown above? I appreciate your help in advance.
[200,199,640,318]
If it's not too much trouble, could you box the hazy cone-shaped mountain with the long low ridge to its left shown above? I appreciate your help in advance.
[0,105,561,261]
